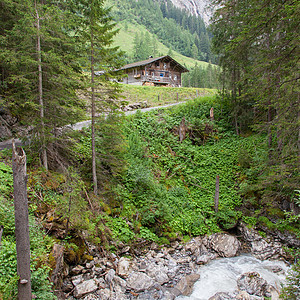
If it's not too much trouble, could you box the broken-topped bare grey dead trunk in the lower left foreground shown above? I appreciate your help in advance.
[12,141,31,300]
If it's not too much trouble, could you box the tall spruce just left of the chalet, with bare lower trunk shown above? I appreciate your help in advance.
[73,0,121,195]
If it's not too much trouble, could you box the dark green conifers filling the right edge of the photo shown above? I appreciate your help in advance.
[213,0,300,213]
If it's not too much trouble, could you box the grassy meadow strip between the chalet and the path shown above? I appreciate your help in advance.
[122,84,216,107]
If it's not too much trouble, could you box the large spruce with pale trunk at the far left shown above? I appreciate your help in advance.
[0,0,82,169]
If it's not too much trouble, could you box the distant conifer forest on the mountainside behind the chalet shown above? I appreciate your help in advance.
[108,0,216,63]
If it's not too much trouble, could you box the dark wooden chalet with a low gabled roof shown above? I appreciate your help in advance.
[121,55,189,87]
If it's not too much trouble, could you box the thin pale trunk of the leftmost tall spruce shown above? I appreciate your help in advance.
[34,1,48,170]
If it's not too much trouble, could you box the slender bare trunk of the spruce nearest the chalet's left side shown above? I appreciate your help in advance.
[91,17,98,195]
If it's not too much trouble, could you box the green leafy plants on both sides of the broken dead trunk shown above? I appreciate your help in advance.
[0,162,54,300]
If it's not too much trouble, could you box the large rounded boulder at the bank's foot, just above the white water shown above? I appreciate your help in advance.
[208,233,240,257]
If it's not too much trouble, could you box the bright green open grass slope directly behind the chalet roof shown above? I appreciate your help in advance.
[114,21,208,68]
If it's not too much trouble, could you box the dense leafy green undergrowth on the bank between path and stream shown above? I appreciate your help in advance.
[112,100,257,236]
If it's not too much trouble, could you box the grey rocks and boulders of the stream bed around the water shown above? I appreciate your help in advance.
[52,224,300,300]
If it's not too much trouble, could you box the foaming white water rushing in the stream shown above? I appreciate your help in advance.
[176,255,288,300]
